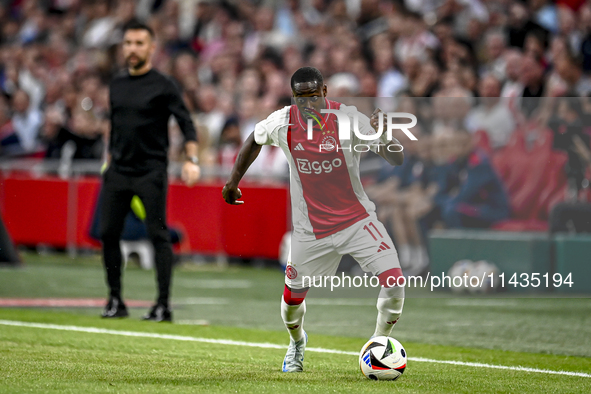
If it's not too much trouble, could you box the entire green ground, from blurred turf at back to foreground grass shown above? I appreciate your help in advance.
[0,255,591,393]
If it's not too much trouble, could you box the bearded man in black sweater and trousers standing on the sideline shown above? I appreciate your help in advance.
[100,22,200,321]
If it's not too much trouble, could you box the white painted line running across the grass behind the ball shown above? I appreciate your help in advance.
[0,320,591,378]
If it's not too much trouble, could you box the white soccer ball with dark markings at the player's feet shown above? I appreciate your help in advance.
[359,336,406,380]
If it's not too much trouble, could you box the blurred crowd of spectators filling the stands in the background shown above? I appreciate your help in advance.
[0,0,591,264]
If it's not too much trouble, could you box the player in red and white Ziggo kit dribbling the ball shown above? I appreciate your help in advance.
[222,67,404,372]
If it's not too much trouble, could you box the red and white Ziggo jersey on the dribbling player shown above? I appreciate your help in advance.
[255,100,385,239]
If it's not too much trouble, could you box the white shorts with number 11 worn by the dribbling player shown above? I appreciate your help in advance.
[285,216,400,289]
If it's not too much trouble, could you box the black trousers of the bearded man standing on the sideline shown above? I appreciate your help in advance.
[100,167,173,306]
